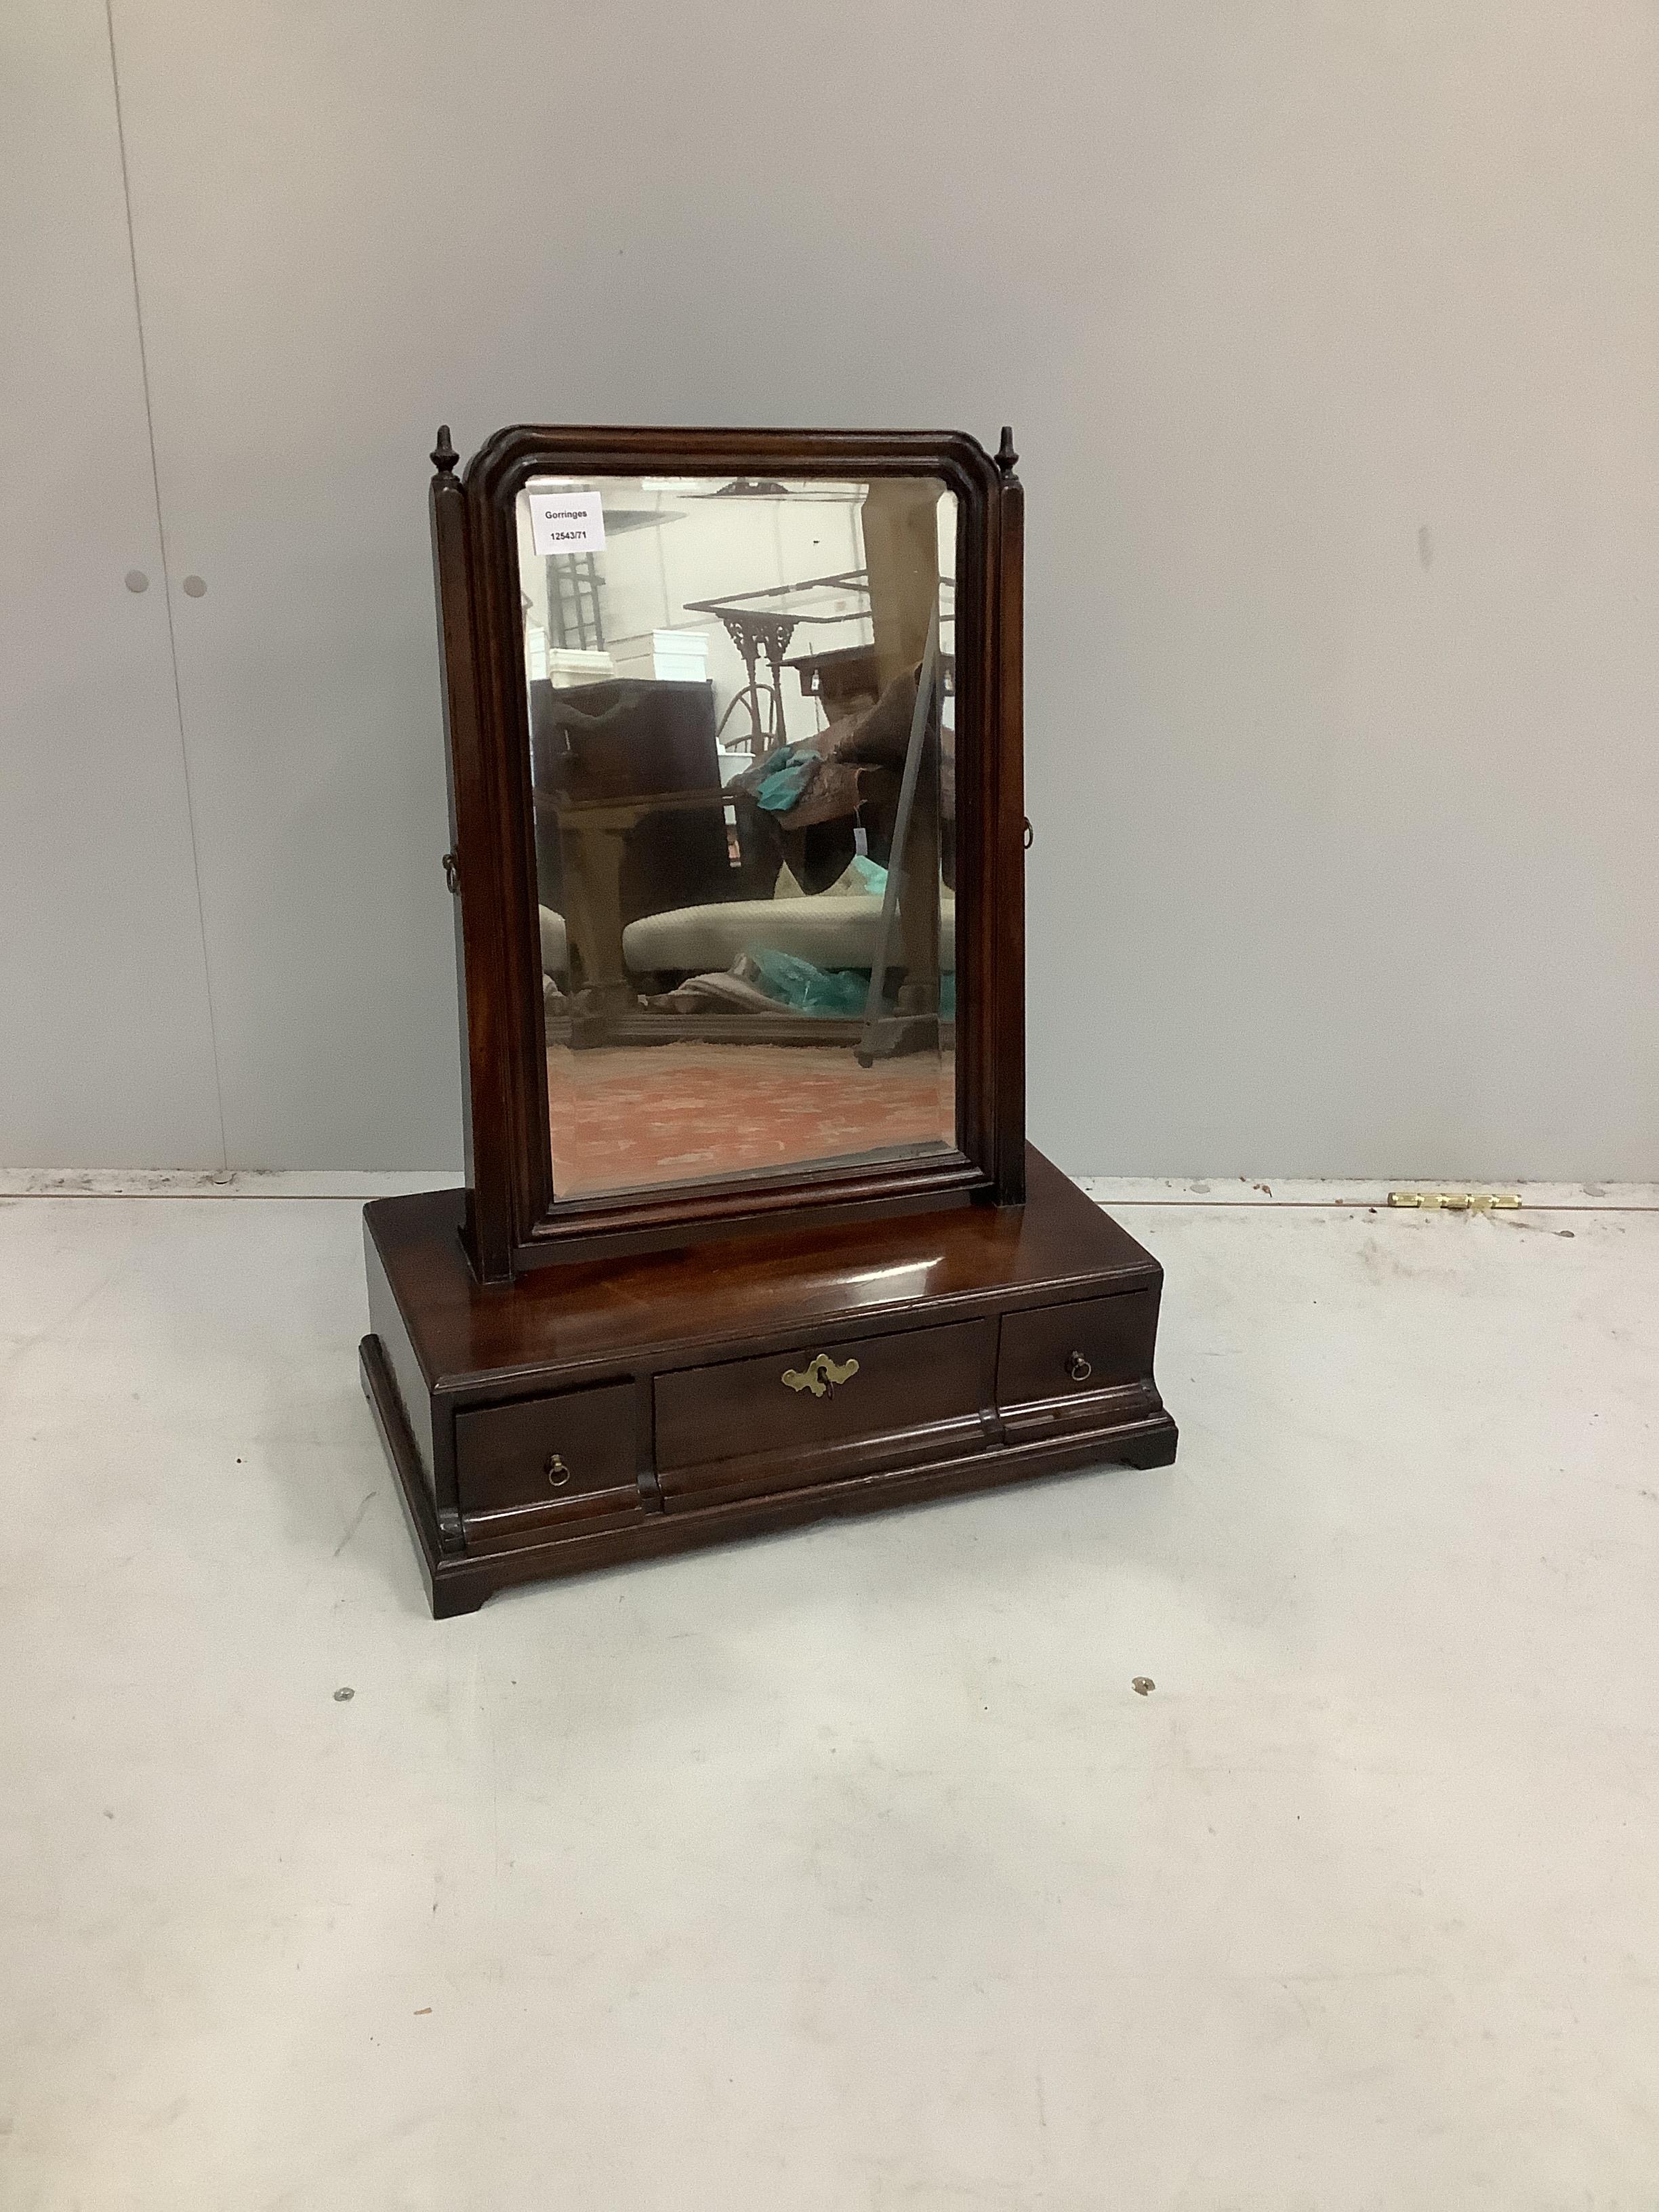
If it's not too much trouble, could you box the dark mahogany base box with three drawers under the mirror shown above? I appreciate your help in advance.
[361,1153,1176,1619]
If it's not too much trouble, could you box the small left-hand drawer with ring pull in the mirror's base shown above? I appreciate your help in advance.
[455,1382,639,1517]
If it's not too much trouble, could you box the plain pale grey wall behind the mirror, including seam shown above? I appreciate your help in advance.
[0,0,1659,1176]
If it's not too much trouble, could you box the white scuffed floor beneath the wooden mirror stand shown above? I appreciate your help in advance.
[0,1192,1659,2212]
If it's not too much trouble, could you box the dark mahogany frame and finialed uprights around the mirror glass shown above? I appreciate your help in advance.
[429,425,1024,1283]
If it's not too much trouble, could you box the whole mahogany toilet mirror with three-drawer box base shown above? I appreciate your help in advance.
[363,427,1174,1612]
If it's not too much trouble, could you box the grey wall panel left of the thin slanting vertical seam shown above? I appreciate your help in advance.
[0,0,224,1168]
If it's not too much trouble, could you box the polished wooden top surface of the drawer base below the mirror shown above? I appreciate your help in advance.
[365,1150,1162,1389]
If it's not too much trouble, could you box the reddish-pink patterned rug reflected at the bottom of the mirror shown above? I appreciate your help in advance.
[546,1044,956,1199]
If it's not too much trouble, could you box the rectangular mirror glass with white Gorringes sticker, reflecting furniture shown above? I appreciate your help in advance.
[518,476,956,1199]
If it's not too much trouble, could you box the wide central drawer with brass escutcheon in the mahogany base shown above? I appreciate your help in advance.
[655,1321,996,1500]
